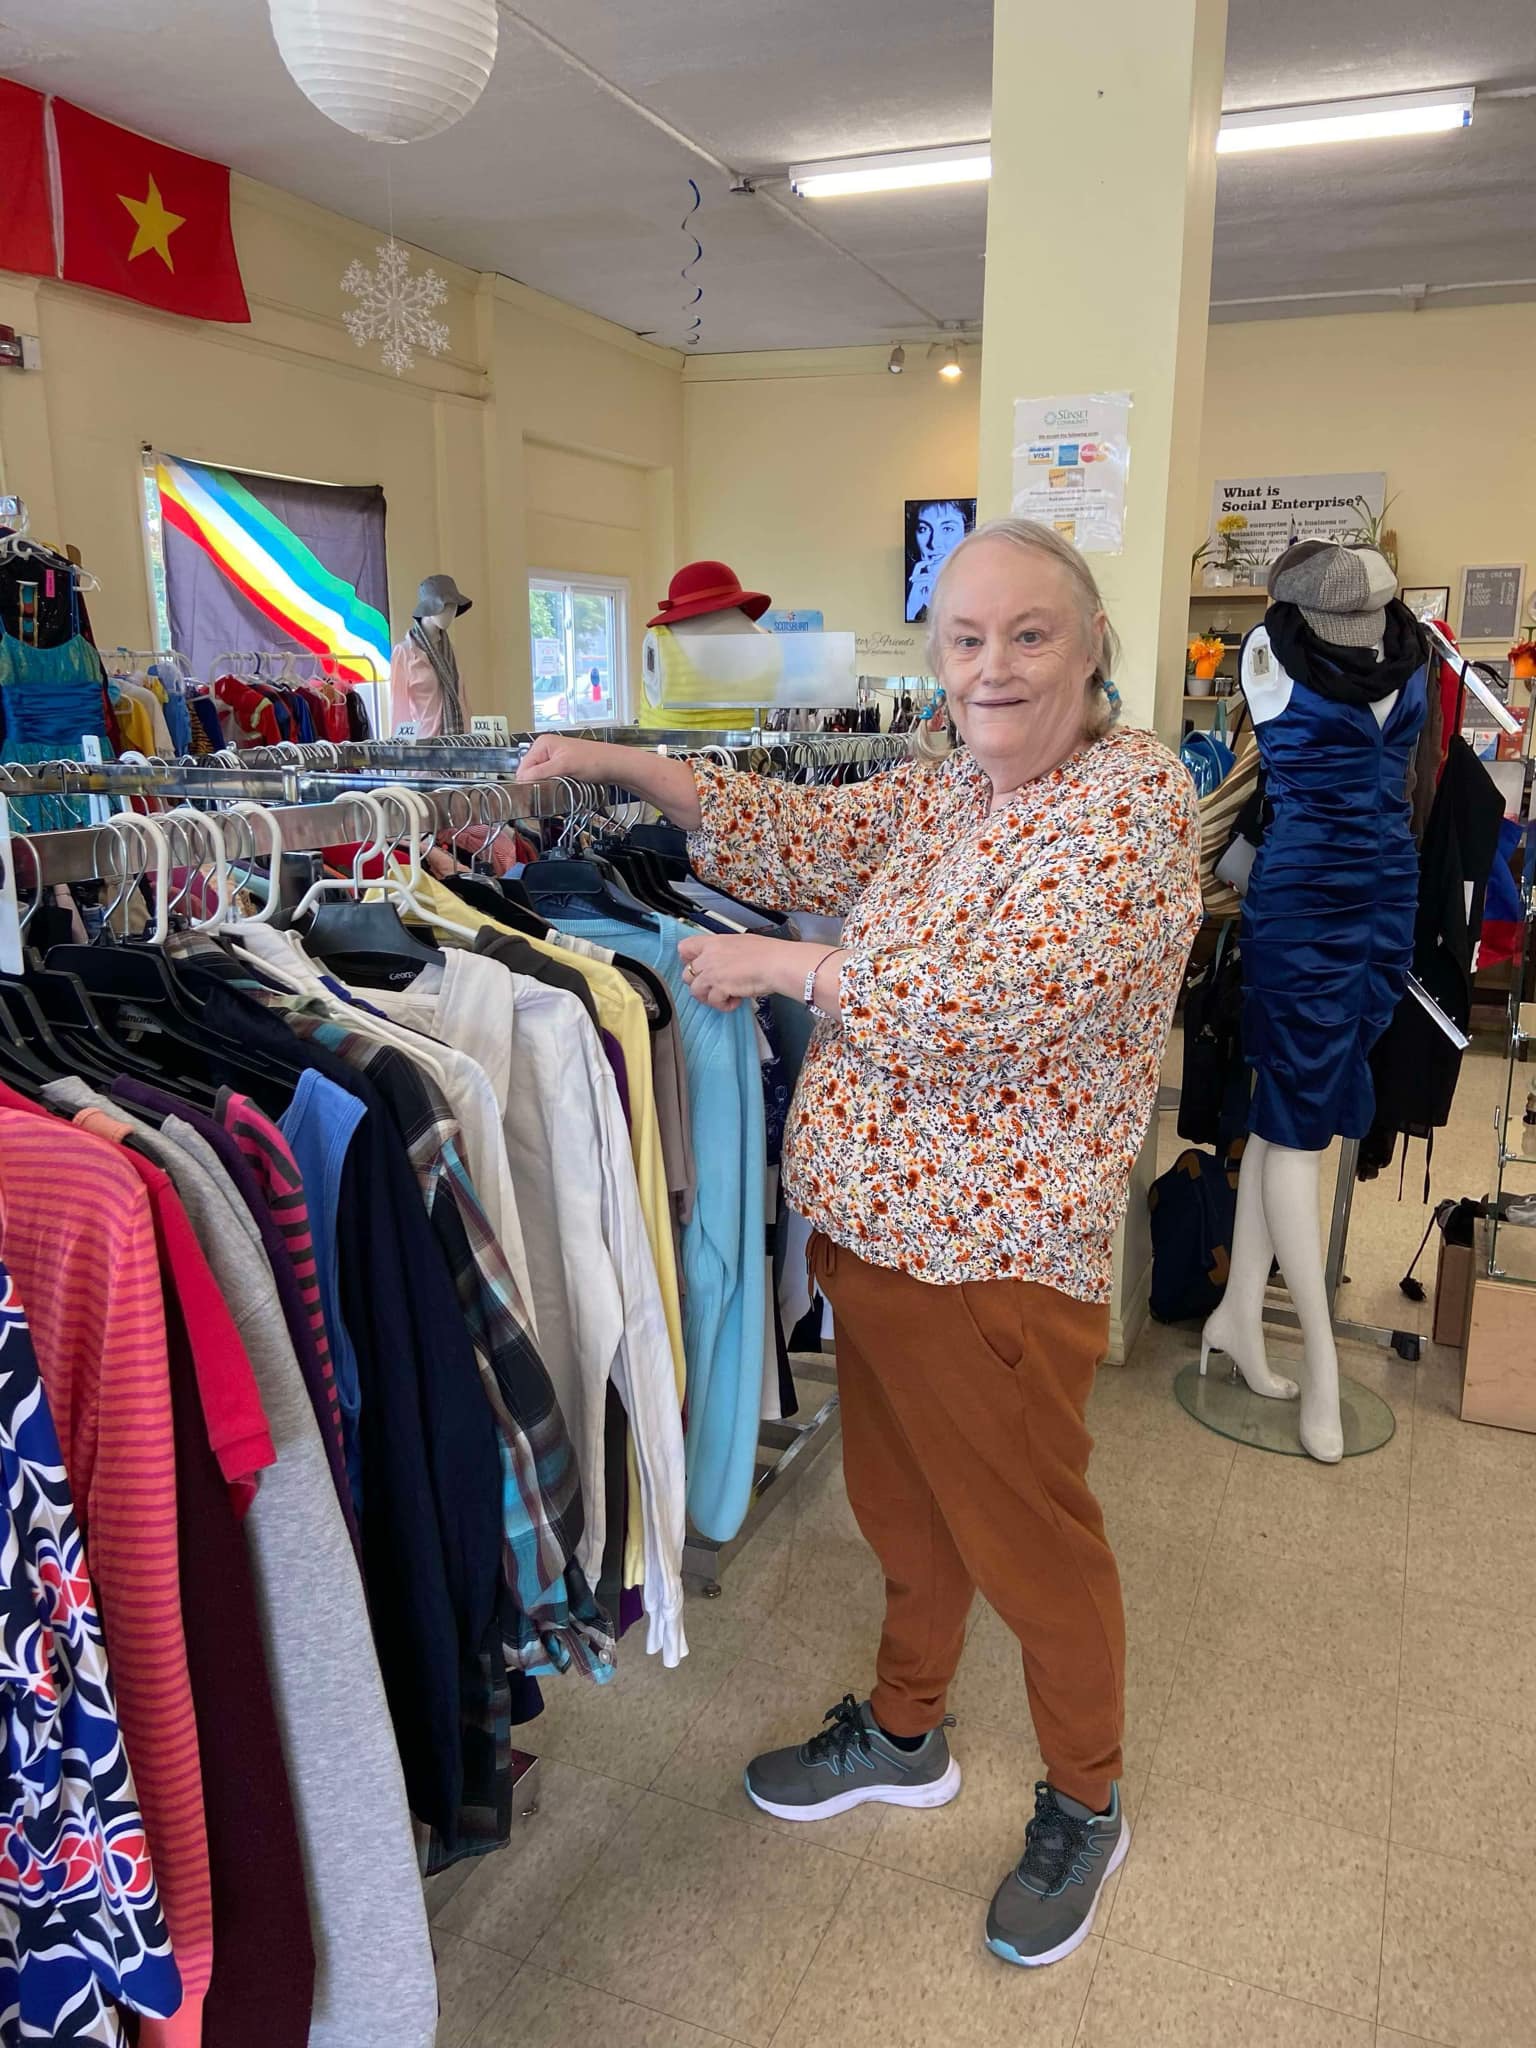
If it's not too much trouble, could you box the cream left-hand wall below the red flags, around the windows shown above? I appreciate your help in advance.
[0,178,682,725]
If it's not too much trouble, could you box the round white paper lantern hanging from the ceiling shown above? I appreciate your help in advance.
[268,0,496,141]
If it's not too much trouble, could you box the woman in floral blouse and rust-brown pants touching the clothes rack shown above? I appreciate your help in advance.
[520,520,1200,1964]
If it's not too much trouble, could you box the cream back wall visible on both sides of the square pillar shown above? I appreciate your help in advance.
[684,305,1536,674]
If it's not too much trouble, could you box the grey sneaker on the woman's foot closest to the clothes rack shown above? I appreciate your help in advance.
[745,1692,961,1821]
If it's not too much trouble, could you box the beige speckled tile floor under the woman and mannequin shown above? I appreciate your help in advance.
[430,1040,1536,2048]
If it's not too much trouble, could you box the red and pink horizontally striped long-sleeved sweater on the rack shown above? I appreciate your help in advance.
[0,1083,213,2040]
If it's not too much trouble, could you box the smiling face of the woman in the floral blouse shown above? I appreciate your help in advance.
[938,541,1104,791]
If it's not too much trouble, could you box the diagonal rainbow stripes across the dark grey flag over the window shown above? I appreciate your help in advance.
[156,455,389,682]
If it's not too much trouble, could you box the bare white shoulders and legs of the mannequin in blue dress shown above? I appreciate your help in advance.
[1200,614,1401,1464]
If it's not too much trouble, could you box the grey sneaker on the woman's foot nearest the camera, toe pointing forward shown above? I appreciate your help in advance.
[987,1782,1130,1968]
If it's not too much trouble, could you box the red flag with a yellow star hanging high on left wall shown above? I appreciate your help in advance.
[53,100,250,319]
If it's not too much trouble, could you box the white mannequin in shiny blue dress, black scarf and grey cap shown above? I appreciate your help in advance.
[1200,543,1425,1464]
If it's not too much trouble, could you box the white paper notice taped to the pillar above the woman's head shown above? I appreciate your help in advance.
[1014,391,1130,555]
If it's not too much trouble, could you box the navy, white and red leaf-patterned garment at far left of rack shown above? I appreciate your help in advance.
[0,1268,182,2044]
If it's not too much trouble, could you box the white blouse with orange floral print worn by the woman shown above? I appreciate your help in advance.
[690,731,1200,1300]
